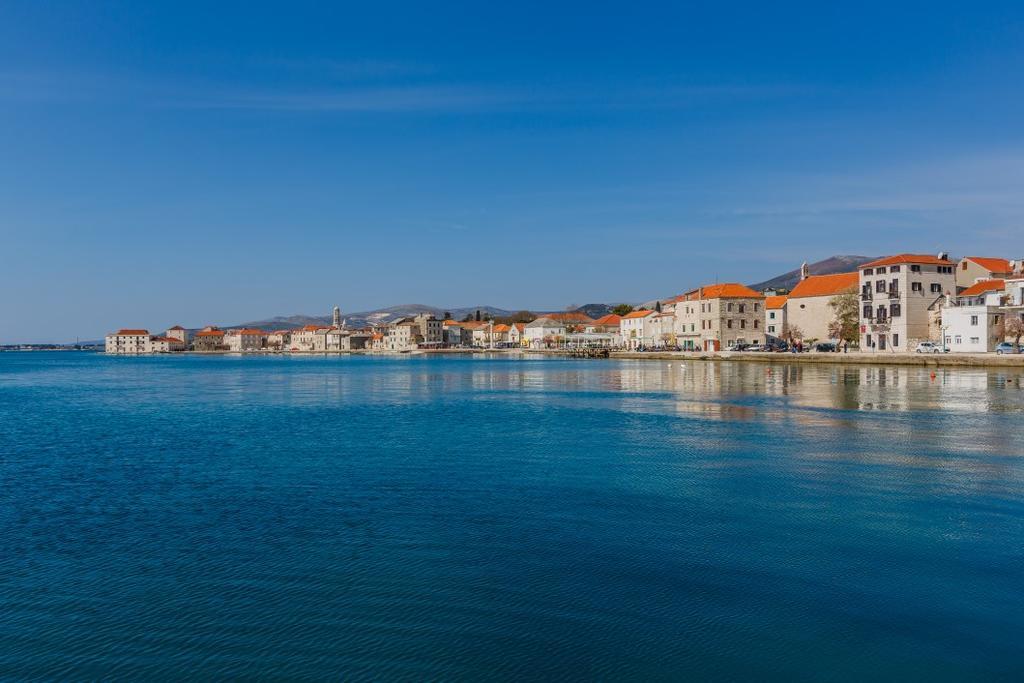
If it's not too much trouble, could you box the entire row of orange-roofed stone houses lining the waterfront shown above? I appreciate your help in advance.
[106,253,1024,353]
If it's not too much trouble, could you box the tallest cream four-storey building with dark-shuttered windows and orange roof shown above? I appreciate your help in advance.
[860,253,956,351]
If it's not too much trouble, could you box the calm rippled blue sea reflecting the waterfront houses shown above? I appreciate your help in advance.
[0,353,1024,680]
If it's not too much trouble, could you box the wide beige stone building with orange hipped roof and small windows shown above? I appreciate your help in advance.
[676,283,765,351]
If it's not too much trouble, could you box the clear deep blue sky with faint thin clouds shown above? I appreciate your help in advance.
[0,1,1024,343]
